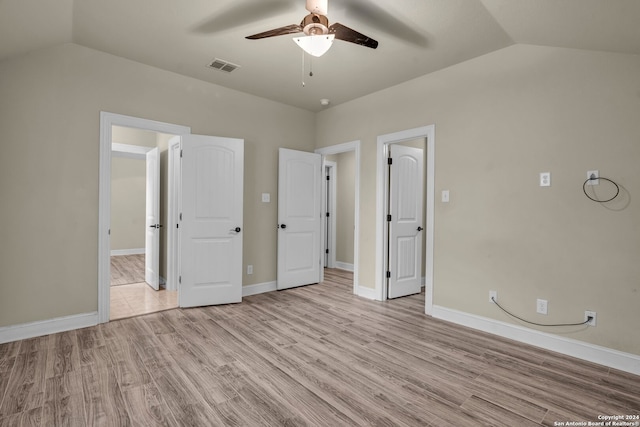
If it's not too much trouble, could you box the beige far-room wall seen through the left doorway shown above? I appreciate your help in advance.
[110,157,147,251]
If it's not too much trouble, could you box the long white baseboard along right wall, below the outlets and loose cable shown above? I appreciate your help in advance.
[433,305,640,375]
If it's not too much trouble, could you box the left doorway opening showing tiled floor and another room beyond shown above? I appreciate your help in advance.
[109,126,177,320]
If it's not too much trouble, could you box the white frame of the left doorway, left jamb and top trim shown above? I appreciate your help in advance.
[98,111,191,323]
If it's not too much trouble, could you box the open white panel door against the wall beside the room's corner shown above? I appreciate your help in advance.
[277,148,322,289]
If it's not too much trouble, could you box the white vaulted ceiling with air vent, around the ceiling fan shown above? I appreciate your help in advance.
[0,0,640,111]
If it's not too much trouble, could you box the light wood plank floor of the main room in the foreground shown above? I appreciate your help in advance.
[0,272,640,426]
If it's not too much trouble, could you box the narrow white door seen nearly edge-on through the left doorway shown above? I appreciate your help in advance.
[144,147,161,291]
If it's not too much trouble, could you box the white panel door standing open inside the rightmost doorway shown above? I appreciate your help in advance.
[387,144,424,298]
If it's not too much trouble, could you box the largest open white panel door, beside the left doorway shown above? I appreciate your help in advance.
[178,135,244,307]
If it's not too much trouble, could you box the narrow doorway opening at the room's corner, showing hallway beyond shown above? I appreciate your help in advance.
[315,141,360,295]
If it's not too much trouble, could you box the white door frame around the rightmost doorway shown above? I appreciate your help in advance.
[375,125,435,315]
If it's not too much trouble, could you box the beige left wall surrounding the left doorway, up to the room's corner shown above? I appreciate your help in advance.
[0,44,315,326]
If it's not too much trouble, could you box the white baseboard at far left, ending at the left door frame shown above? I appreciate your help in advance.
[0,311,98,344]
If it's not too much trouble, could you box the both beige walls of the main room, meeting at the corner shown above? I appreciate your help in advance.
[0,44,640,354]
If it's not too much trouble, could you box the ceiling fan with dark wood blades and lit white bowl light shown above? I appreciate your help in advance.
[246,0,378,56]
